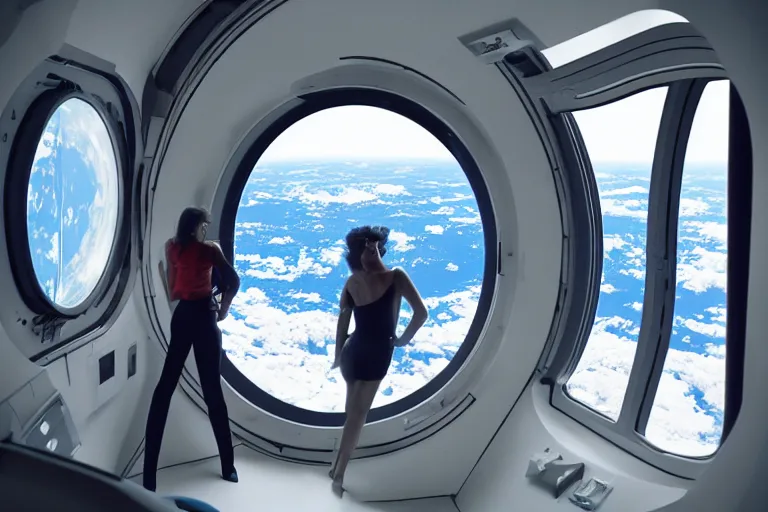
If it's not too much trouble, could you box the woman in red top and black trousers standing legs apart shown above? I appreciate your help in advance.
[143,207,240,491]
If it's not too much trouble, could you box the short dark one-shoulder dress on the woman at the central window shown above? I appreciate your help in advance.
[339,282,397,382]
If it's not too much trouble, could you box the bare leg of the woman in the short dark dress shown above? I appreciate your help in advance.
[333,380,381,496]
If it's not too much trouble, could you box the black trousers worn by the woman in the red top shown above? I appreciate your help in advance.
[143,299,235,491]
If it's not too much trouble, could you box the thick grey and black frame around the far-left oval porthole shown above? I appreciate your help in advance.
[2,52,140,363]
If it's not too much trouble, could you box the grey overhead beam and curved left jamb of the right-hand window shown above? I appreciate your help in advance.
[532,23,727,376]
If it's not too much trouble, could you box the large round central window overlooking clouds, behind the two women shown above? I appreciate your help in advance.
[220,90,495,424]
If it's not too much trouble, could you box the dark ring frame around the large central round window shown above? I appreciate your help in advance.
[218,87,499,427]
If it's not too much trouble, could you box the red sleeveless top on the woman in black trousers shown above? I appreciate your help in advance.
[168,241,216,300]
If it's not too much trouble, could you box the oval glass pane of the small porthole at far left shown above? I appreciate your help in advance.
[27,98,119,308]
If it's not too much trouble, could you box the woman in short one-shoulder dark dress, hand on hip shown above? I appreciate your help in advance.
[329,226,428,496]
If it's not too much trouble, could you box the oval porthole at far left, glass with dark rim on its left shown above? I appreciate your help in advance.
[6,96,120,314]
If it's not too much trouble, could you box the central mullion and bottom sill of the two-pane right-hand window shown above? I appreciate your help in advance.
[550,78,727,479]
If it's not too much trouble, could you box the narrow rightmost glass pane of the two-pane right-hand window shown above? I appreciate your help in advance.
[645,81,729,456]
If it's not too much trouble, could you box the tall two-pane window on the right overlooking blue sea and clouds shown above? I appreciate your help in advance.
[564,80,730,472]
